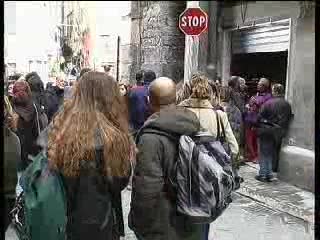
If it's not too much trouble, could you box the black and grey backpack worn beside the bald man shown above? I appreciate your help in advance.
[170,112,239,224]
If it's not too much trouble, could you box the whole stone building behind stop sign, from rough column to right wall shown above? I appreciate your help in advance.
[130,1,315,191]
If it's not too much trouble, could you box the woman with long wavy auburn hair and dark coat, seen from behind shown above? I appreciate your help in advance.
[47,72,132,240]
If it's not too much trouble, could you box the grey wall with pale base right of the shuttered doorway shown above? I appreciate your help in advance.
[279,6,315,192]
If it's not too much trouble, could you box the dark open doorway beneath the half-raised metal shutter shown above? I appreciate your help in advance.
[231,51,288,95]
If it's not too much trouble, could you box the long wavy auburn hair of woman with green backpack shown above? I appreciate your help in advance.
[48,72,131,176]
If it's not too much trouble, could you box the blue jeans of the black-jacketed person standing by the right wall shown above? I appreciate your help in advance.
[258,134,276,178]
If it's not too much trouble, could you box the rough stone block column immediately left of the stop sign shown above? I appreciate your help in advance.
[129,1,186,82]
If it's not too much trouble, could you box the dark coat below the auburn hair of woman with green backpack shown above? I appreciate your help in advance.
[64,149,129,240]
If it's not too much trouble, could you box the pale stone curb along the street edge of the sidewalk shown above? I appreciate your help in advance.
[236,164,314,227]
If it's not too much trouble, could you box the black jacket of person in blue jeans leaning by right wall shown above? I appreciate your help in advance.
[258,97,293,137]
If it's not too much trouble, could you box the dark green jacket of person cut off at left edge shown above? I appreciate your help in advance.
[4,127,21,196]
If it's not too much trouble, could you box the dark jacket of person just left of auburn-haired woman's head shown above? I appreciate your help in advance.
[46,86,64,122]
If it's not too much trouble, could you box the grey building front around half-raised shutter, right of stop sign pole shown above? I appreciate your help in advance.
[209,1,315,191]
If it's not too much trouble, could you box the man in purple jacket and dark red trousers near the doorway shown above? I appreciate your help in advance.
[244,78,272,163]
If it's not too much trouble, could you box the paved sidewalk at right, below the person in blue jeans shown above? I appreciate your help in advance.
[237,163,314,228]
